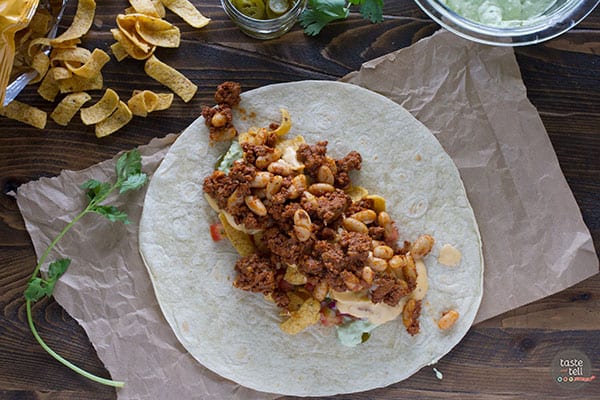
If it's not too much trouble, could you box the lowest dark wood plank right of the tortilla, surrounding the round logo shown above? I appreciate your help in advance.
[284,328,600,400]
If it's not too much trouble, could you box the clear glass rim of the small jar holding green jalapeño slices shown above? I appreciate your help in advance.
[221,0,307,40]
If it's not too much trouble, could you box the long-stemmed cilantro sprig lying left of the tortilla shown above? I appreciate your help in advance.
[24,150,148,387]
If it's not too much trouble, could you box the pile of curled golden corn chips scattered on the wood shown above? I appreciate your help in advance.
[0,0,210,138]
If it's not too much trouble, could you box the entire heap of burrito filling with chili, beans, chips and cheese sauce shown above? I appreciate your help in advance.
[203,83,434,346]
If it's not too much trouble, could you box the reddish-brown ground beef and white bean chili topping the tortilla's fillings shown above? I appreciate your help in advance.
[203,83,432,334]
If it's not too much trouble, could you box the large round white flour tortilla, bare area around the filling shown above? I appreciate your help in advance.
[140,81,483,396]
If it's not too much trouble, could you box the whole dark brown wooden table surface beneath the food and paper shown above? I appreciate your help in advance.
[0,0,600,400]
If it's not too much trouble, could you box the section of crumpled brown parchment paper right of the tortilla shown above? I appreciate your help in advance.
[342,31,598,322]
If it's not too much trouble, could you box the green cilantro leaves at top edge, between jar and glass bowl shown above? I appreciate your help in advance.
[300,0,383,36]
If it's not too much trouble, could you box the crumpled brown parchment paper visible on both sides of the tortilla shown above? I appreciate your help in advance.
[17,31,598,399]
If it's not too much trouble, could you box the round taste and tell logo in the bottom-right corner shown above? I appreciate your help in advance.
[551,349,596,389]
